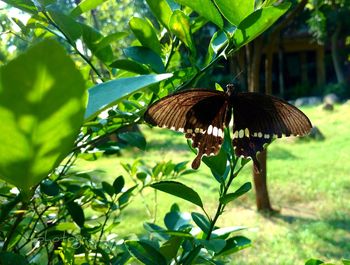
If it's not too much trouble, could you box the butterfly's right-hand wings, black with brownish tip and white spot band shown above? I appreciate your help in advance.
[231,93,312,166]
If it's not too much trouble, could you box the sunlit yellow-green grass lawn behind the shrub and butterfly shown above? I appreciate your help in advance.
[79,104,350,265]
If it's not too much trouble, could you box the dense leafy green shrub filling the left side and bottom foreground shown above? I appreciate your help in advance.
[0,0,346,264]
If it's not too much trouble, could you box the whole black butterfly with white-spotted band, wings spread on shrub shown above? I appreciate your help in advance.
[144,85,312,169]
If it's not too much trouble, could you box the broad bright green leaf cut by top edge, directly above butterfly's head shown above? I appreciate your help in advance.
[214,0,255,26]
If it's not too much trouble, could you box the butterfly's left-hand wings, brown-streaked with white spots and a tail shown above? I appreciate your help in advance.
[144,89,230,169]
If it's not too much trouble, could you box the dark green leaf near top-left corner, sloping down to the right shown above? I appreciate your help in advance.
[49,9,82,42]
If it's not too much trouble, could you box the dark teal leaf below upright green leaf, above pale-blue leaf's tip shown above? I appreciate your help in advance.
[124,46,165,73]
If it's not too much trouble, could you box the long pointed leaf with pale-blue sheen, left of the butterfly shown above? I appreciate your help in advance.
[85,74,172,120]
